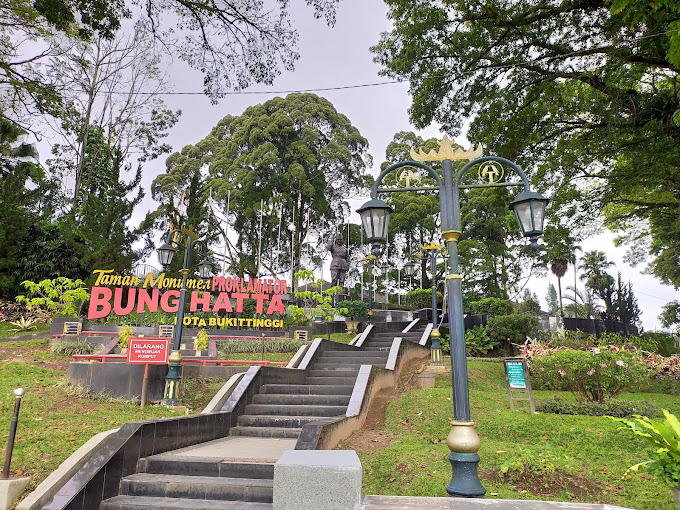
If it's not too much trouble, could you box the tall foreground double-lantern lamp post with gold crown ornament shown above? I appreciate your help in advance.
[357,137,548,497]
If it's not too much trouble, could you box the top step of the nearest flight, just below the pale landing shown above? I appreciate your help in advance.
[137,456,274,480]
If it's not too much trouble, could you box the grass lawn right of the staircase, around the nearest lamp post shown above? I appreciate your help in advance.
[339,358,680,510]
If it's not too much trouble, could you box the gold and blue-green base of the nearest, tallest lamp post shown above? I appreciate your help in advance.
[446,420,486,498]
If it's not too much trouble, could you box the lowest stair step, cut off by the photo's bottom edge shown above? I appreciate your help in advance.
[99,496,274,510]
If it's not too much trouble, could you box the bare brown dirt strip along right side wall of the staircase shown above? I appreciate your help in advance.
[343,360,424,452]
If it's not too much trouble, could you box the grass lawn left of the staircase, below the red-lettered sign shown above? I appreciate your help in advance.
[0,339,224,491]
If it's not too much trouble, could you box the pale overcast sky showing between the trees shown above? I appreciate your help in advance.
[41,0,680,330]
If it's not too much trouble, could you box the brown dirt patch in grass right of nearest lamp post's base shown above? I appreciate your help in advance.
[480,468,604,501]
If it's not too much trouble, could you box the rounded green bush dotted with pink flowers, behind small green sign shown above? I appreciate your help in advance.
[531,347,647,403]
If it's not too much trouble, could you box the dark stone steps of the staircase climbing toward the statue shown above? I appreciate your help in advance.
[99,322,422,510]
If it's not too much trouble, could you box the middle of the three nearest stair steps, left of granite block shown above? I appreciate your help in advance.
[120,473,274,503]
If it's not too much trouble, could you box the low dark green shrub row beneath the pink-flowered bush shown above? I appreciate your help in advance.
[536,396,660,418]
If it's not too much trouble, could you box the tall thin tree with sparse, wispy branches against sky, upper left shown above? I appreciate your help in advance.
[48,28,181,215]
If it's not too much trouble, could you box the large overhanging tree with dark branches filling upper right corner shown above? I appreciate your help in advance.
[373,0,680,286]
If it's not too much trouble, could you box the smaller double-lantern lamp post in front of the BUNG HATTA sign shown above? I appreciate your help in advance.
[156,226,212,406]
